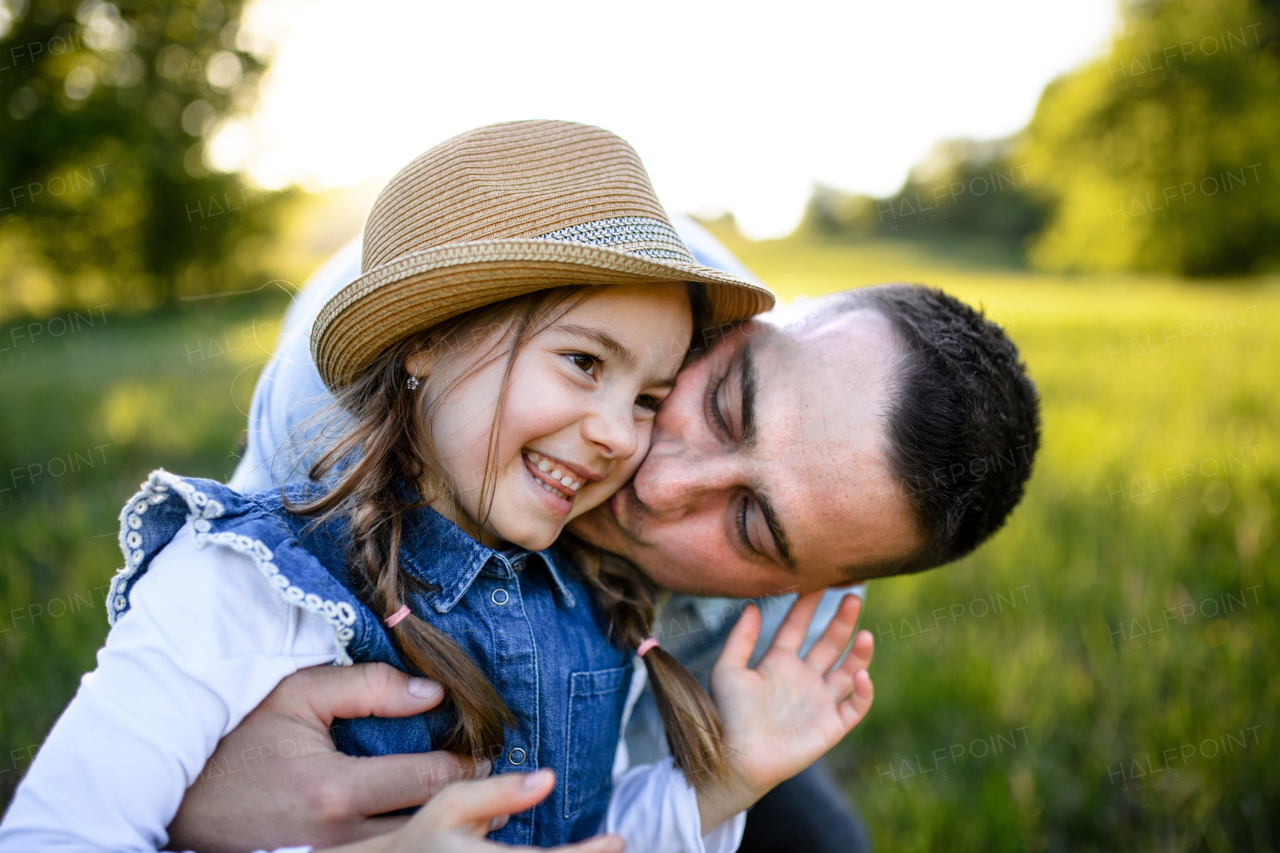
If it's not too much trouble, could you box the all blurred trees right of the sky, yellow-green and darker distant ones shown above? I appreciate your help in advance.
[800,0,1280,277]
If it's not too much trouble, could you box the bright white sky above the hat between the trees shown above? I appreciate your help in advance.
[222,0,1116,237]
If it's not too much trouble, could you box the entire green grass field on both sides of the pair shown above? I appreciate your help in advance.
[0,235,1280,853]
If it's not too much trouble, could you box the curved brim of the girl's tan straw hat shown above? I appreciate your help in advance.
[311,238,774,391]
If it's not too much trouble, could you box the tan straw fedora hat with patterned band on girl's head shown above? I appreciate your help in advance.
[311,122,773,391]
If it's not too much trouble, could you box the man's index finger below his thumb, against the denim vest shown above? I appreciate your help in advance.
[342,752,490,816]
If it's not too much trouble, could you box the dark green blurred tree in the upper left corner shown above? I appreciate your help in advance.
[0,0,285,314]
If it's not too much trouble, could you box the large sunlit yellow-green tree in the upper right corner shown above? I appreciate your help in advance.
[1016,0,1280,275]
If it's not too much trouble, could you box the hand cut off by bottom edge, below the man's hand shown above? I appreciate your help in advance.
[321,770,623,853]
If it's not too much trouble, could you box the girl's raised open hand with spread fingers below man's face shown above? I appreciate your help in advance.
[699,590,874,831]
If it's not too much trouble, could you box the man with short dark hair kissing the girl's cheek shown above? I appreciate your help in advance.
[174,216,1038,852]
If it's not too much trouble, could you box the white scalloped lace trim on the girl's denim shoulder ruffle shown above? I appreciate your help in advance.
[106,469,356,666]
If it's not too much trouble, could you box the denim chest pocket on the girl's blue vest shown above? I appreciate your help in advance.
[564,666,634,817]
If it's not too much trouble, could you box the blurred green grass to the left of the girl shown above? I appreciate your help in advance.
[0,288,285,802]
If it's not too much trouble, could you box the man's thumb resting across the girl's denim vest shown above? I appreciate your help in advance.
[269,663,444,727]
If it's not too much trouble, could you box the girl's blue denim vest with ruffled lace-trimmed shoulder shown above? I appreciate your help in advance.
[106,470,632,847]
